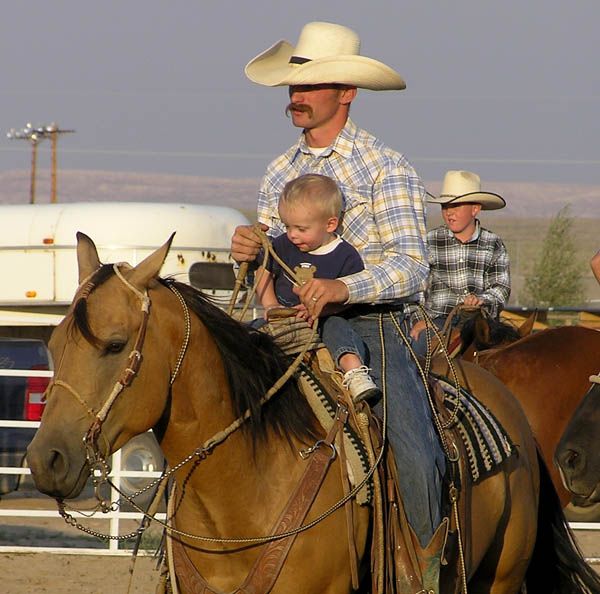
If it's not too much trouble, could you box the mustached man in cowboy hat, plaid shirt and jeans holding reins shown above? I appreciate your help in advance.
[231,22,445,545]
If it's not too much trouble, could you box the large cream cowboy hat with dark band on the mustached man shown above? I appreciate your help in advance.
[244,22,406,91]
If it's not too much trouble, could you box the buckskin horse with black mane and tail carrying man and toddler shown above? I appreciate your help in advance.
[28,233,599,594]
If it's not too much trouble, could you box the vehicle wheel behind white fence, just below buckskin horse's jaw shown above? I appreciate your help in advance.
[121,432,164,508]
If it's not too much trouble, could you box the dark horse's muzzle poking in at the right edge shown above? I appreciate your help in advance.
[555,374,600,507]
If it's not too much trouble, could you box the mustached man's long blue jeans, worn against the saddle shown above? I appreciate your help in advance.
[342,310,446,546]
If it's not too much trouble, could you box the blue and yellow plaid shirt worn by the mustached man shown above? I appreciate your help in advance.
[258,120,428,303]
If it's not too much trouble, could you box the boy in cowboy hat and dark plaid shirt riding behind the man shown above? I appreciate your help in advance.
[410,171,510,355]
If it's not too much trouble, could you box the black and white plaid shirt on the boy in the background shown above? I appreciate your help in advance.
[415,221,510,319]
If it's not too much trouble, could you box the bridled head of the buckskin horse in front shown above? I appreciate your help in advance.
[27,233,173,498]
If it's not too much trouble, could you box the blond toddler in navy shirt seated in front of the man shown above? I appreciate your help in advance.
[256,173,381,402]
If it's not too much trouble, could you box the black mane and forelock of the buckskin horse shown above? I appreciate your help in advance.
[73,264,318,444]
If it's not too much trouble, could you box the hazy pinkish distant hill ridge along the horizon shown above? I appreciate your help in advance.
[0,169,600,219]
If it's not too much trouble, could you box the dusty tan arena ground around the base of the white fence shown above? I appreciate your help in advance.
[0,494,600,594]
